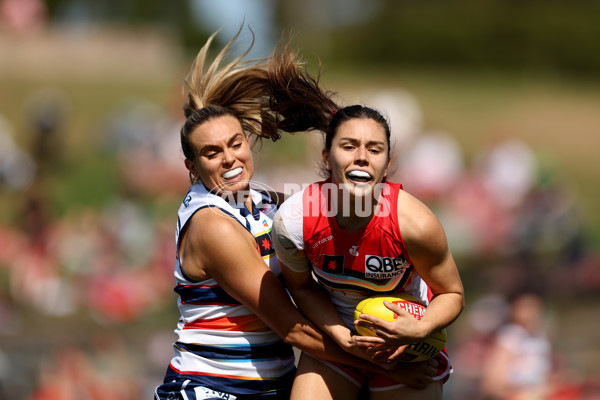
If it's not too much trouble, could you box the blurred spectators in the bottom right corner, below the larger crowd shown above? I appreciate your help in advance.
[446,289,600,400]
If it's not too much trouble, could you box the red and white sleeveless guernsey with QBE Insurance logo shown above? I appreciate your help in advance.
[277,181,428,330]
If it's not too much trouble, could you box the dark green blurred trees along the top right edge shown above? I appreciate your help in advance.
[277,0,600,75]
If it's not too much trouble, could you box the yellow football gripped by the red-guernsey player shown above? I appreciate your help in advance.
[354,293,446,362]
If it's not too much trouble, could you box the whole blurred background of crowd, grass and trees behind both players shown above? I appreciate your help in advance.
[0,0,600,399]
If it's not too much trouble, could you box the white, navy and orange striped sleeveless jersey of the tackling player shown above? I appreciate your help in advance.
[165,183,295,395]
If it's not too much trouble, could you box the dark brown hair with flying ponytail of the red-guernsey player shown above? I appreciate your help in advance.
[269,42,391,157]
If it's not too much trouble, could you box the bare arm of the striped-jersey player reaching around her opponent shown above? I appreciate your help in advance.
[181,209,372,365]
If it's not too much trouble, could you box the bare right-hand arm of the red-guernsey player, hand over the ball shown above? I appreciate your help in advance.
[358,191,464,347]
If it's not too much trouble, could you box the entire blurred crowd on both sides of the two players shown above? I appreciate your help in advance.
[0,83,600,400]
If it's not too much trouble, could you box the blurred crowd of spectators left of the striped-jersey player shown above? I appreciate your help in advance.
[0,89,187,400]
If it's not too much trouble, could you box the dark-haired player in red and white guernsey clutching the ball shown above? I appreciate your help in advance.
[271,48,464,399]
